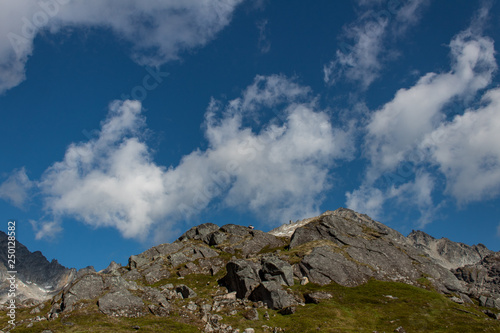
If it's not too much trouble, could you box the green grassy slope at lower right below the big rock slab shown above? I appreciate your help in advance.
[225,281,500,333]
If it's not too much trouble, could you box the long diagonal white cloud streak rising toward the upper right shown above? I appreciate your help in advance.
[366,30,497,183]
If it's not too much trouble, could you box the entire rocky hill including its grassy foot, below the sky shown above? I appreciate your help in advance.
[0,208,500,332]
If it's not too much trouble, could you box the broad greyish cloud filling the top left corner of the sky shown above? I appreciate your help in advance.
[0,0,242,93]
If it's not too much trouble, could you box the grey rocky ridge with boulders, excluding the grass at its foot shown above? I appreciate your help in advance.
[0,208,500,332]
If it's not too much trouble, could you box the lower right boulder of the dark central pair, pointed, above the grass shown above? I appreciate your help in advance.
[248,281,296,310]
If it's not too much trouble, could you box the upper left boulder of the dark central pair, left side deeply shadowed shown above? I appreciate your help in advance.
[220,259,260,298]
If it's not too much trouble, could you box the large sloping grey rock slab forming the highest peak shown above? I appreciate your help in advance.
[290,209,464,292]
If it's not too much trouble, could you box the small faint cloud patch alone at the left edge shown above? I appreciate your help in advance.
[0,168,33,207]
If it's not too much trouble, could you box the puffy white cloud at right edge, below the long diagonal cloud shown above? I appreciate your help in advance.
[422,88,500,203]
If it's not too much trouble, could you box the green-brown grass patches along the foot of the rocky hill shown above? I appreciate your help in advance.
[0,277,500,333]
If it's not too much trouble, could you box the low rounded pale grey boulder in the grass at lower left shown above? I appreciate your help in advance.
[98,289,144,318]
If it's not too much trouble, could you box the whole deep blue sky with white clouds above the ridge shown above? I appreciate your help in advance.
[0,0,500,269]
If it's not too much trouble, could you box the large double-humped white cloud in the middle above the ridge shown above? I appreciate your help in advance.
[33,75,353,238]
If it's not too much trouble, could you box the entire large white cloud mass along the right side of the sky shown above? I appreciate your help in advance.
[346,8,500,226]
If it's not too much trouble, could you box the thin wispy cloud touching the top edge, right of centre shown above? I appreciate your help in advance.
[323,0,428,89]
